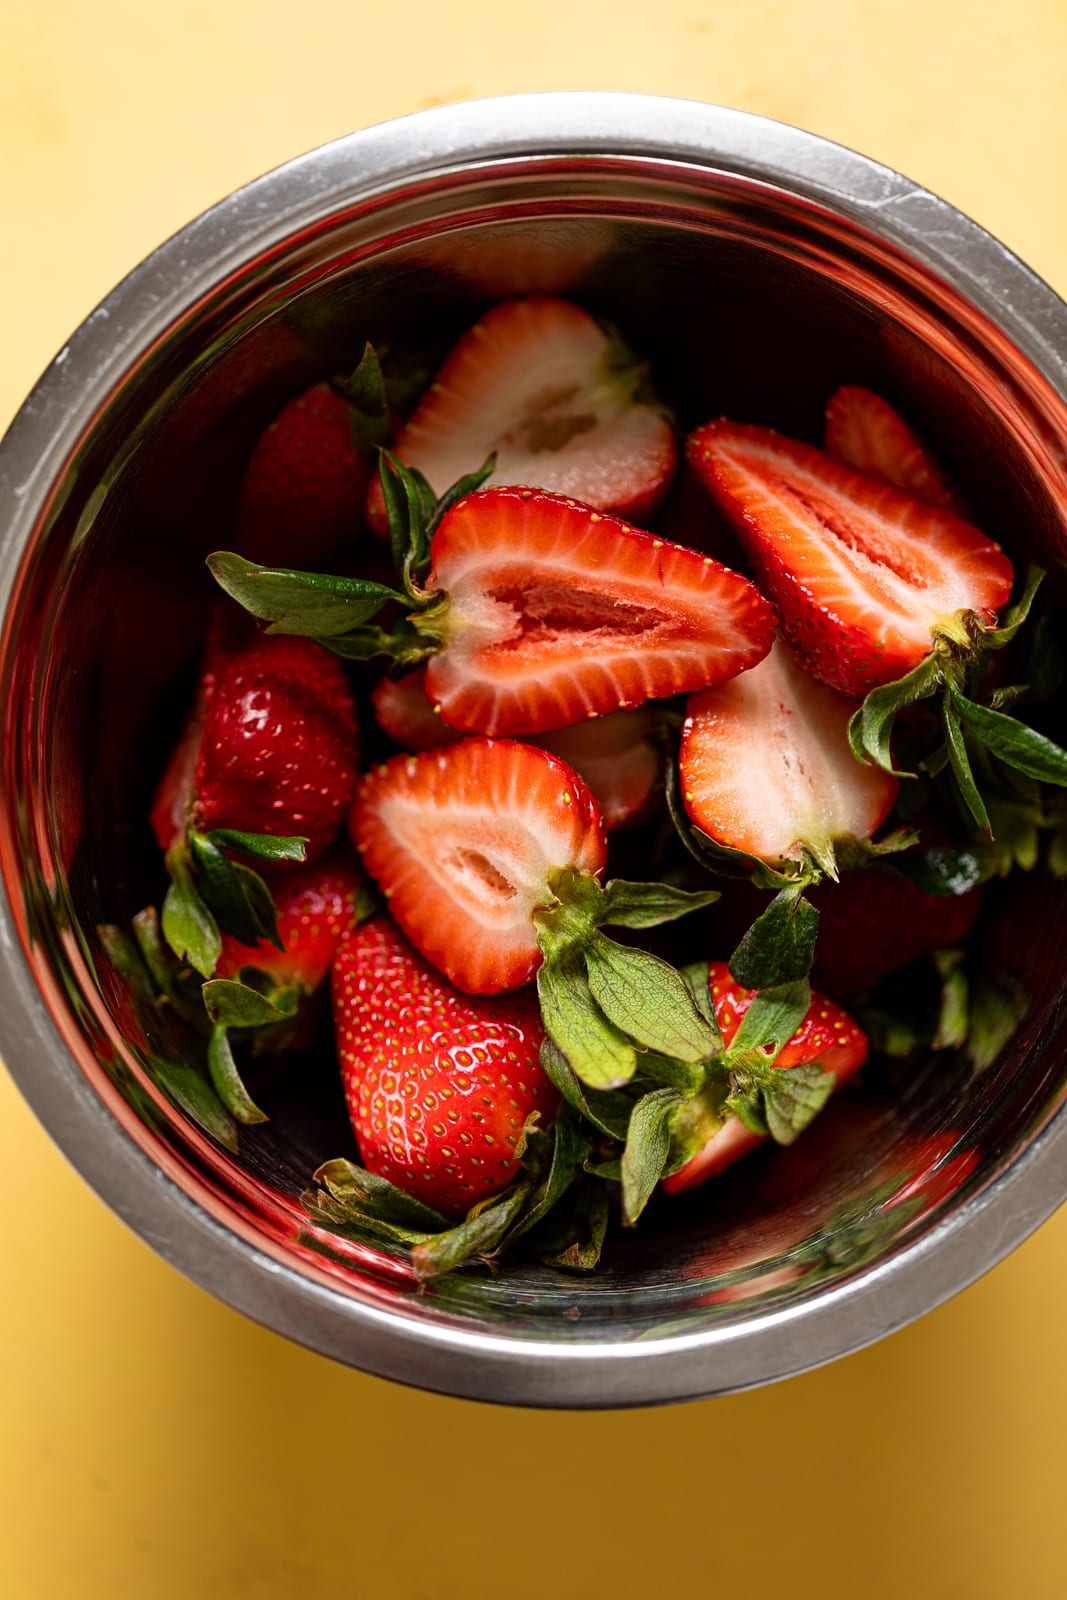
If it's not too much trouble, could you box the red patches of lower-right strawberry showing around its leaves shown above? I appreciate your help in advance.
[664,962,867,1194]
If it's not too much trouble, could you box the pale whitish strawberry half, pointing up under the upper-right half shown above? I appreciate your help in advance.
[678,642,899,874]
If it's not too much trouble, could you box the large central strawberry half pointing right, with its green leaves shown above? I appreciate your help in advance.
[208,462,773,736]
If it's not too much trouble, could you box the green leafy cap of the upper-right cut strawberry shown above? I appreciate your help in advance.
[849,566,1067,838]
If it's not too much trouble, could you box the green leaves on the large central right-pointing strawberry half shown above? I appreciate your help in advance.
[208,450,496,667]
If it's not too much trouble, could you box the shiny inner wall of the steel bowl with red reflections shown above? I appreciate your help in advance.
[3,144,1067,1376]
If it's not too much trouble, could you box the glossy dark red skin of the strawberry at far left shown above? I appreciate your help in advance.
[192,635,358,861]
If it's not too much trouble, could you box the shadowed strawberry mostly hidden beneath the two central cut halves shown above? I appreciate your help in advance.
[371,667,662,832]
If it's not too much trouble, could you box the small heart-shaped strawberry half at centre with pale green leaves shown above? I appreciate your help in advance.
[350,739,718,1085]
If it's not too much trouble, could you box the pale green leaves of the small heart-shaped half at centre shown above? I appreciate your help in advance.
[534,870,718,1090]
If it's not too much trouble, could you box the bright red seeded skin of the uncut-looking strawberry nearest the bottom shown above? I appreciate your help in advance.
[331,917,558,1218]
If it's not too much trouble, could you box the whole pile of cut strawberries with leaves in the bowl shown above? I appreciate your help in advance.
[115,296,1067,1277]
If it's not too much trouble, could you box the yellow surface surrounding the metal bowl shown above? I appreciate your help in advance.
[0,0,1067,1600]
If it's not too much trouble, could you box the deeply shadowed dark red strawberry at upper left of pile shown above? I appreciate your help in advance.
[237,382,373,571]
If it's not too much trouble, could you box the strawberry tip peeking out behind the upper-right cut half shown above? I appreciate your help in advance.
[824,384,966,515]
